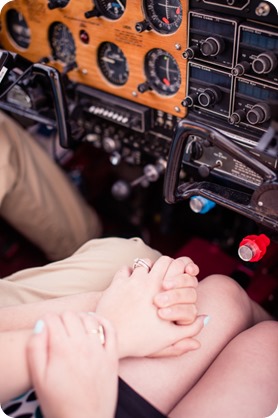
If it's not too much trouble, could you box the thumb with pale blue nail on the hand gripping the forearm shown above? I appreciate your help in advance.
[26,319,48,386]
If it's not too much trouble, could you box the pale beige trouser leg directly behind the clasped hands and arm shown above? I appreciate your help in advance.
[0,238,161,307]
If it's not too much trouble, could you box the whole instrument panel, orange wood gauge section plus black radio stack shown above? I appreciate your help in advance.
[0,0,278,209]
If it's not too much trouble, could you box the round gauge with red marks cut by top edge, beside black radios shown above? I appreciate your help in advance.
[143,0,182,34]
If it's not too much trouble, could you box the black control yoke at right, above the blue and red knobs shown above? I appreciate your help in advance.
[164,119,278,232]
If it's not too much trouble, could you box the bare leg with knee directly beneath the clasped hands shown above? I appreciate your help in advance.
[120,275,268,414]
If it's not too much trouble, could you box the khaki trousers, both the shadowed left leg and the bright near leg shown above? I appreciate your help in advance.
[0,113,159,306]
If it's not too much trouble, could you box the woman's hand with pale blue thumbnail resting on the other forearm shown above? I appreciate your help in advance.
[27,312,118,418]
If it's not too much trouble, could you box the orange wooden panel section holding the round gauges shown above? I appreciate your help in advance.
[1,0,188,117]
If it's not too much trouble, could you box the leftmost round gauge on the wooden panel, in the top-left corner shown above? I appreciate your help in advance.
[6,9,31,48]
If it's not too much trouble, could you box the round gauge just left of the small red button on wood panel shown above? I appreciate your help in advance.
[49,22,76,64]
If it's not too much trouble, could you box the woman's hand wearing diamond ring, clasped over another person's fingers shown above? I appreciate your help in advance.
[96,256,205,358]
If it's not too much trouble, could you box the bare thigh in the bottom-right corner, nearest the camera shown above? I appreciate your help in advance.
[170,321,278,418]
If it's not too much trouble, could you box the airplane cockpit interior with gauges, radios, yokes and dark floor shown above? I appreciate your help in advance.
[0,0,278,318]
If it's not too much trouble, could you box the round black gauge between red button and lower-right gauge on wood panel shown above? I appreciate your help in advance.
[98,42,129,86]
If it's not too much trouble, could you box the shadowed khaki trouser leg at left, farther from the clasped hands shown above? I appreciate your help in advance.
[0,112,101,260]
